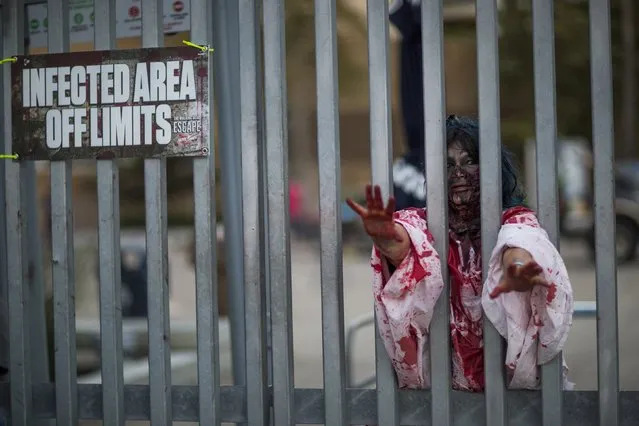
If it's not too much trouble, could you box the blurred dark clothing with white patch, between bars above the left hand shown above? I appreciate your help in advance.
[390,0,426,209]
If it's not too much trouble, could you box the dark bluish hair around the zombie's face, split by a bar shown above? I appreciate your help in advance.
[446,115,526,209]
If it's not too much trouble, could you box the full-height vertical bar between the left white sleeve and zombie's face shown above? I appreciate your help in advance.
[422,0,452,426]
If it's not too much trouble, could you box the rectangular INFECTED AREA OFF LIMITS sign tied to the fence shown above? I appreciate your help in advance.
[11,47,210,160]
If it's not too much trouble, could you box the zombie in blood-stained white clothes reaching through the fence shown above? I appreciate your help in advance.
[348,116,573,392]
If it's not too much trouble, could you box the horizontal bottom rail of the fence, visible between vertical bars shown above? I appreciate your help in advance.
[0,383,639,426]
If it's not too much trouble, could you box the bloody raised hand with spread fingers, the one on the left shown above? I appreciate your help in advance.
[346,185,402,242]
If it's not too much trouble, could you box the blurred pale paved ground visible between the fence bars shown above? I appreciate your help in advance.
[75,228,639,425]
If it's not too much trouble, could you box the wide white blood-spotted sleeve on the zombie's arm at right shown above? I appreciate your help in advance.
[482,213,573,389]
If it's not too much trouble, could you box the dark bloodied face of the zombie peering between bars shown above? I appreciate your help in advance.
[448,142,479,209]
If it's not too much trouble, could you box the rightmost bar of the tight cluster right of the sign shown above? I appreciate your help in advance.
[264,0,295,426]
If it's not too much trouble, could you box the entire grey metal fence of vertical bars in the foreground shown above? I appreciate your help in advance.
[0,0,639,426]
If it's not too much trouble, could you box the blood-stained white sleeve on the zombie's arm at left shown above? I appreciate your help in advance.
[371,208,443,389]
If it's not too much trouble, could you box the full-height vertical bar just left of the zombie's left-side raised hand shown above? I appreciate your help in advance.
[315,0,348,426]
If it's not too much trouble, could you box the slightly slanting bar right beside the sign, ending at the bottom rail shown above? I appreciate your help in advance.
[213,0,246,398]
